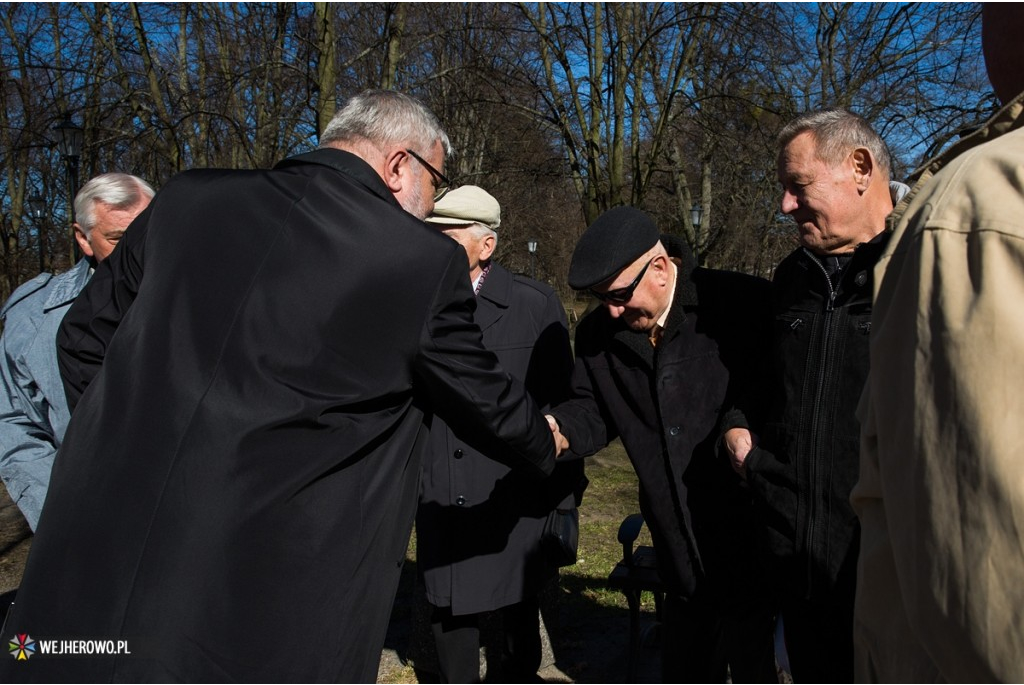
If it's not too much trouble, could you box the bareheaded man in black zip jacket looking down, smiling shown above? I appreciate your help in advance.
[724,110,905,682]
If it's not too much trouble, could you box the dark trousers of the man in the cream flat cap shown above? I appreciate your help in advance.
[430,597,541,683]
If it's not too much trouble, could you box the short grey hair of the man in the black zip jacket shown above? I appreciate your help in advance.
[777,109,892,178]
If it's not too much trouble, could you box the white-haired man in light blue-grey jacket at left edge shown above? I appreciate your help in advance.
[0,173,154,530]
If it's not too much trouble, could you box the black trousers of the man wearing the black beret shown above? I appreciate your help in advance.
[662,595,778,683]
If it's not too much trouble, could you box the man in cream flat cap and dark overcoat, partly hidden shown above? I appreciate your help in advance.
[416,185,585,683]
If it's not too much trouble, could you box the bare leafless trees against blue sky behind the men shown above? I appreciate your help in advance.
[0,2,995,295]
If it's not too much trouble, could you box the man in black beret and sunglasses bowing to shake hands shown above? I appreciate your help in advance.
[552,207,777,682]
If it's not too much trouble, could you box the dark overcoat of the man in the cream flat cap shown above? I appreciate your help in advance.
[416,263,584,615]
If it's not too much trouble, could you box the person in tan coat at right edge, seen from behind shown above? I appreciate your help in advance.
[851,4,1024,683]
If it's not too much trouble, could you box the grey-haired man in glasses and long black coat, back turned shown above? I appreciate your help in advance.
[0,91,555,682]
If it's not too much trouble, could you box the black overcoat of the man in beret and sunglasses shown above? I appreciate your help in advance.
[553,237,769,602]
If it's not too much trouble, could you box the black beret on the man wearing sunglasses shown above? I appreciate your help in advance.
[569,207,660,290]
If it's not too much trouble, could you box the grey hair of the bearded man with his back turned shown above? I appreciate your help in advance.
[319,90,452,157]
